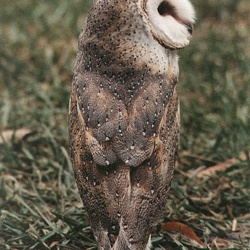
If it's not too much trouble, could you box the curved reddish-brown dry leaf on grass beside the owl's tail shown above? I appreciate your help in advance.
[161,222,206,247]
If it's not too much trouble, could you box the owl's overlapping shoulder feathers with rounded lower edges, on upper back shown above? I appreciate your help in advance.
[69,69,178,169]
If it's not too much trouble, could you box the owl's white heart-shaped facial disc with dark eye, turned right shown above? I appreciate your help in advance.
[141,0,195,49]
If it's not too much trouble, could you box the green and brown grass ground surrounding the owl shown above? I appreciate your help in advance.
[0,0,250,250]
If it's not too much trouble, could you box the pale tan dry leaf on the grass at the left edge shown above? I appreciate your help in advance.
[0,128,32,144]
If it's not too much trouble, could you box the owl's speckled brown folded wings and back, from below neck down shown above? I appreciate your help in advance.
[69,68,179,249]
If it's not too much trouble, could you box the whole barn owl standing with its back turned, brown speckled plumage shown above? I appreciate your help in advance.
[69,0,195,250]
